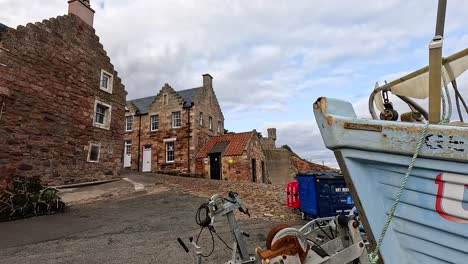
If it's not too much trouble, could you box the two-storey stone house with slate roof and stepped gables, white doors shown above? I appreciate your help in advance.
[124,74,224,173]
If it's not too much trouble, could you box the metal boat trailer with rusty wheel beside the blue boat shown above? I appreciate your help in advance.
[177,192,369,264]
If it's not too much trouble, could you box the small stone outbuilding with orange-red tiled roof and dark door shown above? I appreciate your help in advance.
[196,130,274,183]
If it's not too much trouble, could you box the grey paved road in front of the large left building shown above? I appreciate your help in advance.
[0,191,286,264]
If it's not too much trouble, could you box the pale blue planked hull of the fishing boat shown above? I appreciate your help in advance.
[314,98,468,263]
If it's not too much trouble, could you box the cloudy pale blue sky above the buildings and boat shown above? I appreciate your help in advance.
[0,0,468,165]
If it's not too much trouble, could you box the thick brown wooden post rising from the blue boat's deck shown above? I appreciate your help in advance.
[429,36,442,124]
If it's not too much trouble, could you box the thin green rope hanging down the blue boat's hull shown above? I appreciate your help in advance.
[369,122,429,264]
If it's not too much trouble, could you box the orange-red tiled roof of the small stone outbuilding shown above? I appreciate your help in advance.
[198,131,253,158]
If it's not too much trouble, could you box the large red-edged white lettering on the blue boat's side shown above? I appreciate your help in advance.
[435,173,468,224]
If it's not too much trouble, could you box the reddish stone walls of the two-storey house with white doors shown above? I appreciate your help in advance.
[125,77,224,173]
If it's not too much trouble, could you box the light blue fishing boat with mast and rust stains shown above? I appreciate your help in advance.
[314,0,468,263]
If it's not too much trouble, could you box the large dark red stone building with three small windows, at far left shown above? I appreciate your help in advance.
[0,0,127,188]
